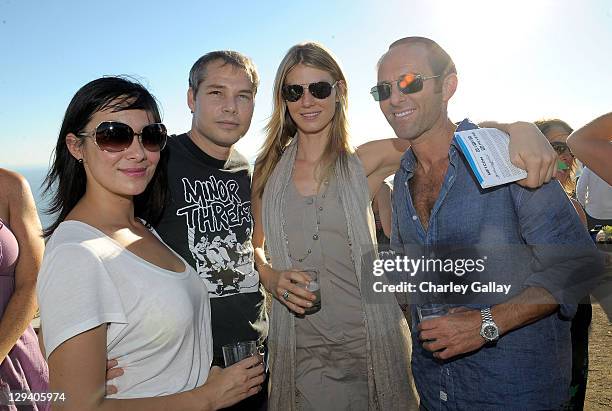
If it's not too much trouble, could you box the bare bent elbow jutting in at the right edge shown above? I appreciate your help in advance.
[567,112,612,185]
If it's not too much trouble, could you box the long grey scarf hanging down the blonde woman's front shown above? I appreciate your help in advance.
[262,138,418,411]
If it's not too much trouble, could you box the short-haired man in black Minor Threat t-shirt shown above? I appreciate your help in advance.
[155,51,267,410]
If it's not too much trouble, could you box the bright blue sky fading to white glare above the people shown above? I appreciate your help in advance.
[0,0,612,169]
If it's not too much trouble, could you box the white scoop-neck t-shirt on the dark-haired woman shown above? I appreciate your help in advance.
[37,221,212,398]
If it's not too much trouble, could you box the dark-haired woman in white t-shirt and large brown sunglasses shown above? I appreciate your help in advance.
[38,77,263,410]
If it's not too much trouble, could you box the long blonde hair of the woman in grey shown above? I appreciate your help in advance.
[253,42,353,198]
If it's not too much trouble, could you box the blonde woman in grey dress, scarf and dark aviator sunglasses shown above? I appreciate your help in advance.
[251,43,550,410]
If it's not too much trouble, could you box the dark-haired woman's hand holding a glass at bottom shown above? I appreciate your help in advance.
[194,355,266,410]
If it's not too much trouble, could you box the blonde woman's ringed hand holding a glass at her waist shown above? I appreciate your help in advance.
[266,266,316,315]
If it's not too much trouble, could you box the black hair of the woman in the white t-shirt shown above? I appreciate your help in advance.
[43,77,168,237]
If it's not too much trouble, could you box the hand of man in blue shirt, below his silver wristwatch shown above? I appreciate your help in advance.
[418,307,485,360]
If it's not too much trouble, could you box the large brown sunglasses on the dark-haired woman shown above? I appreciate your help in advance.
[77,121,168,153]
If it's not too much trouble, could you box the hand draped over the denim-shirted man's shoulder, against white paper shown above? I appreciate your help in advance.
[480,121,557,188]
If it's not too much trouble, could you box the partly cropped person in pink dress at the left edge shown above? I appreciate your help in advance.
[0,168,49,411]
